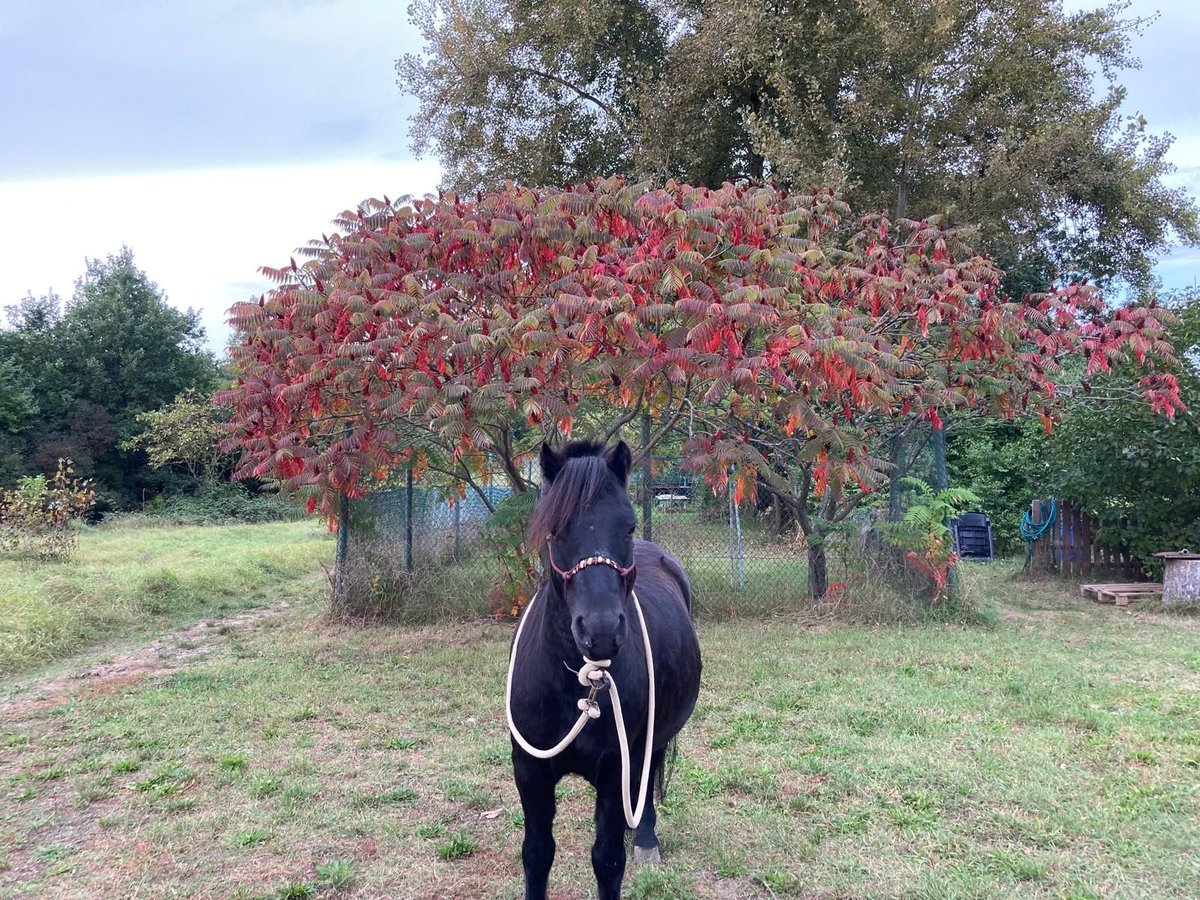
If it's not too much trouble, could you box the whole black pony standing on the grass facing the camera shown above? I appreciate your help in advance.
[509,442,701,900]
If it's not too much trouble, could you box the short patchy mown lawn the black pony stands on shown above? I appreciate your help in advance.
[0,568,1200,899]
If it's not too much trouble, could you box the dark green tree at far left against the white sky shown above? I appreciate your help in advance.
[0,248,217,500]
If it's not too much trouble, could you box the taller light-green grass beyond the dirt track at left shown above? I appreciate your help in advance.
[0,521,332,673]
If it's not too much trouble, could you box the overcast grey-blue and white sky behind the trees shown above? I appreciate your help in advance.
[0,0,1200,346]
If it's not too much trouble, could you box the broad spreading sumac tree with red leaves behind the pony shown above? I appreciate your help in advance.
[222,179,1178,596]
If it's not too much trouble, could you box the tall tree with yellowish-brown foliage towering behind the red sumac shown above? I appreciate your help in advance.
[397,0,1200,295]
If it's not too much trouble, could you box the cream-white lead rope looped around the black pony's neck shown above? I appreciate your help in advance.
[504,590,654,828]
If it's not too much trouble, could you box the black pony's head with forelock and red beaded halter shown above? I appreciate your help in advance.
[530,440,637,660]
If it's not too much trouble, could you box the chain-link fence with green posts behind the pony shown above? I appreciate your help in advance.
[343,457,838,622]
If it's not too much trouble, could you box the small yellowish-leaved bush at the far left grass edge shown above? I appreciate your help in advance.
[0,460,96,560]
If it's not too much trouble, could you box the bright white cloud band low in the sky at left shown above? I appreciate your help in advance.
[0,161,439,349]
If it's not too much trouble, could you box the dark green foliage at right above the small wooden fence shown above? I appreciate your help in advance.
[950,290,1200,570]
